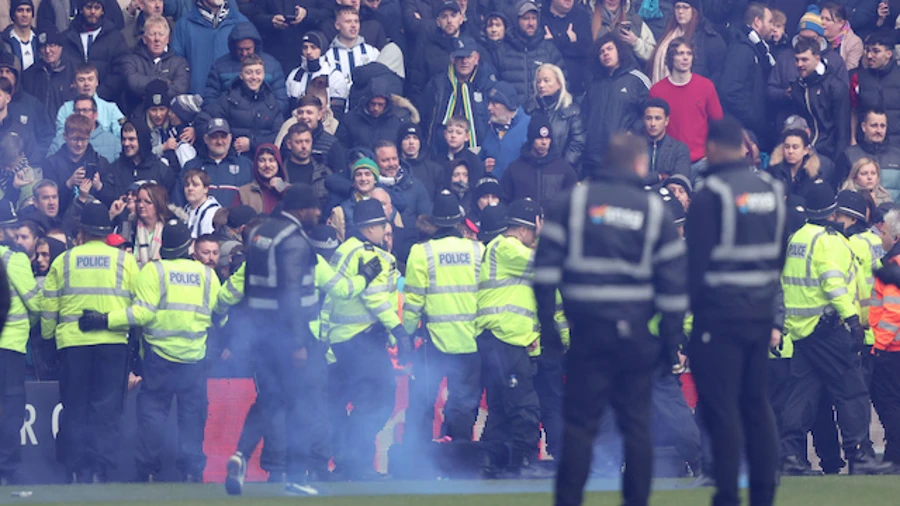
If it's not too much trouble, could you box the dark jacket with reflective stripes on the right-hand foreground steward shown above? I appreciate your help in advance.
[685,161,787,327]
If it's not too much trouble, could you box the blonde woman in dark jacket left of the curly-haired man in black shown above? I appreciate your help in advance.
[525,63,587,167]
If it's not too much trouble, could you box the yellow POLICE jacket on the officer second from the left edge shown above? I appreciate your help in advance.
[41,241,139,349]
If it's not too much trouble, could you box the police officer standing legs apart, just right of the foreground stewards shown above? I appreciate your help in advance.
[781,184,892,474]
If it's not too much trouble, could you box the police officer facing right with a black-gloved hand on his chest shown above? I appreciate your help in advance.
[323,199,411,480]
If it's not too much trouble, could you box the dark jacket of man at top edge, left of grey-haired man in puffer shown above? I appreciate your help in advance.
[63,0,128,101]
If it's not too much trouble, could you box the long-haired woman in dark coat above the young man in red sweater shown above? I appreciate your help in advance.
[649,0,726,83]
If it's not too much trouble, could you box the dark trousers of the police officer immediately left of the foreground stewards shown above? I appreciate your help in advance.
[478,331,540,467]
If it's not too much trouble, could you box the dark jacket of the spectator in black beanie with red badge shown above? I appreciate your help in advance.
[500,144,578,209]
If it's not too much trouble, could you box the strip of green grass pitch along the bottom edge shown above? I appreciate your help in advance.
[0,476,900,506]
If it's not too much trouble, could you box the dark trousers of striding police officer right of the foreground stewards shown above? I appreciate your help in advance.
[781,324,871,459]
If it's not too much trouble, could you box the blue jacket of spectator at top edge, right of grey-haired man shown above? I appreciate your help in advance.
[172,1,247,94]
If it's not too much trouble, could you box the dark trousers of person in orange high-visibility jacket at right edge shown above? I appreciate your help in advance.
[872,352,900,464]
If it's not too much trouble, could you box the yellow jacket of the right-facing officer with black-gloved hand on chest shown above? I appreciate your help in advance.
[323,237,400,344]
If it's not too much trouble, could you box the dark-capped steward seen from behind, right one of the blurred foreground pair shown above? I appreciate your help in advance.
[686,118,786,505]
